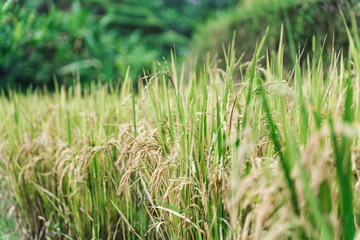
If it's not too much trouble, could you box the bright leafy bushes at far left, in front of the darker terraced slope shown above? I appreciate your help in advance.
[0,2,163,88]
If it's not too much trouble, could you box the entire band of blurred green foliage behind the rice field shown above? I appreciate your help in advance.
[0,0,360,88]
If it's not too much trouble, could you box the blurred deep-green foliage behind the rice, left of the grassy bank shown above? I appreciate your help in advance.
[0,0,234,89]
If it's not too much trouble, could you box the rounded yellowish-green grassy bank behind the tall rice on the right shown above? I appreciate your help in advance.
[191,0,360,66]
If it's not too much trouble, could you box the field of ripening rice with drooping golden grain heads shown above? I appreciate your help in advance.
[0,23,360,240]
